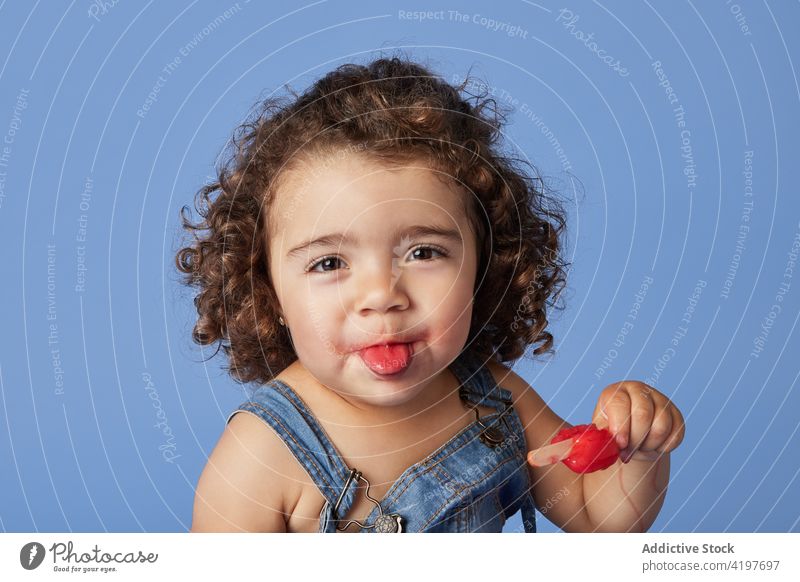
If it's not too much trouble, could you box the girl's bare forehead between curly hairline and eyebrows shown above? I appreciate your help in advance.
[270,154,468,243]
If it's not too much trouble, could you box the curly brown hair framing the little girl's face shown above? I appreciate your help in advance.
[176,56,566,383]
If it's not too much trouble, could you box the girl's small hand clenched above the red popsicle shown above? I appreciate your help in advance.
[592,381,686,463]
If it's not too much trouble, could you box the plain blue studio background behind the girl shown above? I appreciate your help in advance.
[0,0,800,532]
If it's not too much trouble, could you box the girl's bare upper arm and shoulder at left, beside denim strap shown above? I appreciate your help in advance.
[191,411,295,532]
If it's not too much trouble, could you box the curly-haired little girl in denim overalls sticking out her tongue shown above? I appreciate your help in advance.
[177,58,684,532]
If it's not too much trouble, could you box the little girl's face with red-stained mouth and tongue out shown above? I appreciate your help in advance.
[269,155,477,409]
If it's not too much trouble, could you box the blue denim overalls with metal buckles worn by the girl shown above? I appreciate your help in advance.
[228,351,536,533]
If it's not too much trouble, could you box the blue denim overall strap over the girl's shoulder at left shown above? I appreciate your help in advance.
[226,378,355,508]
